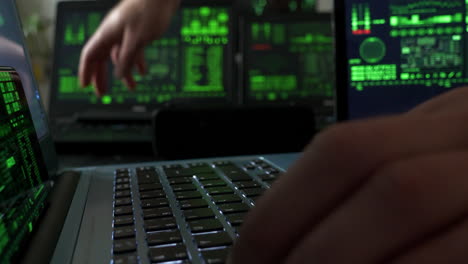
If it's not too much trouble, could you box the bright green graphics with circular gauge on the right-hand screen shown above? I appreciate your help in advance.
[347,0,468,92]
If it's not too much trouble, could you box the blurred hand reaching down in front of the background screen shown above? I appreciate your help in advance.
[79,0,179,95]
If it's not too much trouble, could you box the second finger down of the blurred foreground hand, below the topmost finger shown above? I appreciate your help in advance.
[286,152,468,264]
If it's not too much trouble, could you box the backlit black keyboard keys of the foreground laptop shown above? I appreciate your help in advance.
[112,159,281,264]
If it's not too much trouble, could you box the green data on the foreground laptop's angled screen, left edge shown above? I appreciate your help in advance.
[0,71,47,263]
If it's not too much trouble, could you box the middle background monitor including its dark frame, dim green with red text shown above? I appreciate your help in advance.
[241,14,334,128]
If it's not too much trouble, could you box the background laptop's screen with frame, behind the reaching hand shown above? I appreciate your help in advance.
[50,1,233,116]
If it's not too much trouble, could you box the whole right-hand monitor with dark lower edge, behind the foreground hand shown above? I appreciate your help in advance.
[335,0,468,120]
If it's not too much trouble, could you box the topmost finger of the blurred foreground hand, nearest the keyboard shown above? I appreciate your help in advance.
[233,112,468,263]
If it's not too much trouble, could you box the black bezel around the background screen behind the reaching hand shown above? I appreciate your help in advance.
[48,0,238,118]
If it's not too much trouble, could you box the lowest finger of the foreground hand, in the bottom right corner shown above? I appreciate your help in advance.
[390,214,468,264]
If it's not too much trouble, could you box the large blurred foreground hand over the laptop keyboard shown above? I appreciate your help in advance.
[230,88,468,264]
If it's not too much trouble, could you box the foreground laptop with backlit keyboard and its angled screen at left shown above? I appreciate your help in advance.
[0,0,298,264]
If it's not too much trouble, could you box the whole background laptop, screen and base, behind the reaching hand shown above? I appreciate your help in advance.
[49,0,236,148]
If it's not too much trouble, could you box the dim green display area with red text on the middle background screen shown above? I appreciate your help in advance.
[245,21,334,102]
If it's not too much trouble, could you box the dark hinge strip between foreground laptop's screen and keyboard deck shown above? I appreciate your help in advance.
[21,172,80,263]
